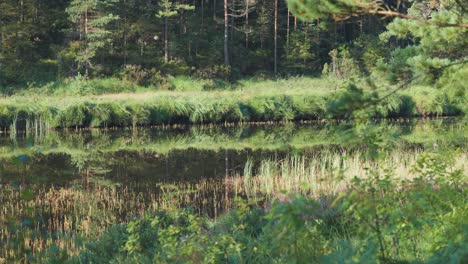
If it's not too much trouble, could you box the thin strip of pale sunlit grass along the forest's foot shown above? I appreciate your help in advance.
[0,75,336,96]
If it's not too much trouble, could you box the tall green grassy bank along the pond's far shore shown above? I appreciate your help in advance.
[0,78,467,131]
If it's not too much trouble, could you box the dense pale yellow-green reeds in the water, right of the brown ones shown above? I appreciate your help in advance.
[238,151,468,198]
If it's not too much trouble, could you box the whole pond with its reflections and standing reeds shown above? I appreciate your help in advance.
[0,119,468,256]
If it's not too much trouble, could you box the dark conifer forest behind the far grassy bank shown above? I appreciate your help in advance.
[0,0,392,86]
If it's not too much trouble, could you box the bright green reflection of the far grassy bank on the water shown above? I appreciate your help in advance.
[0,120,468,158]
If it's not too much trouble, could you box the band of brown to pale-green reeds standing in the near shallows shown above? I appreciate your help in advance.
[0,151,468,260]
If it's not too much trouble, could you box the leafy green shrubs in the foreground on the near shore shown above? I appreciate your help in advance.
[39,148,468,263]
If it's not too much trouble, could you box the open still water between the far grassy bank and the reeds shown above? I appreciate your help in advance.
[0,119,467,186]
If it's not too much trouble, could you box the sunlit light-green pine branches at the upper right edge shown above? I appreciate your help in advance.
[380,0,468,84]
